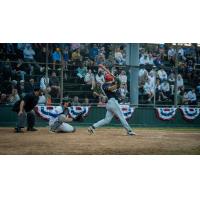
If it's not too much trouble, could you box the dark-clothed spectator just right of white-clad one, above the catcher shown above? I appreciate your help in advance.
[49,71,60,98]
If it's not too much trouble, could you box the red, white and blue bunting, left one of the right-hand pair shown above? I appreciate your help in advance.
[156,108,177,120]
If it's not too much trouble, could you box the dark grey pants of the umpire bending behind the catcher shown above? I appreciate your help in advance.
[17,110,35,128]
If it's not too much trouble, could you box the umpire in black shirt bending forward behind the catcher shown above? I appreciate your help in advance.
[12,86,41,133]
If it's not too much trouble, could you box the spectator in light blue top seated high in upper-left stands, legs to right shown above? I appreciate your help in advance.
[23,44,40,75]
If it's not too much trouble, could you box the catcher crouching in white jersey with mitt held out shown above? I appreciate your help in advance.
[49,99,83,133]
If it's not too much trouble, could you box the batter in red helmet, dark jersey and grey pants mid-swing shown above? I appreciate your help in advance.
[88,73,135,135]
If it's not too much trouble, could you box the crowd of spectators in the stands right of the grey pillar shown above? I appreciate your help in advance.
[139,45,200,105]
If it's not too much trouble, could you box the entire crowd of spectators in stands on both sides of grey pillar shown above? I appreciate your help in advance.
[0,43,200,106]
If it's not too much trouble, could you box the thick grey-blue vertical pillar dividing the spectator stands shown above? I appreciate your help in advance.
[126,43,139,106]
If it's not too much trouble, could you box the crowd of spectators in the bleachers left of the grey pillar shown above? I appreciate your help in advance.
[0,43,127,105]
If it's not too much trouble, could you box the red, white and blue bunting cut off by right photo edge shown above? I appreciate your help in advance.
[180,106,200,120]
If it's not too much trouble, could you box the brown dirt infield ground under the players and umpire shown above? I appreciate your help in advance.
[0,128,200,155]
